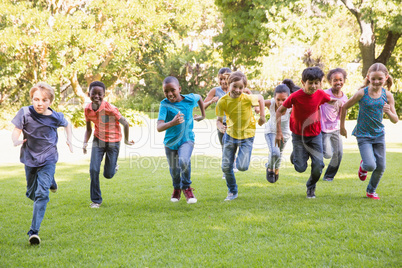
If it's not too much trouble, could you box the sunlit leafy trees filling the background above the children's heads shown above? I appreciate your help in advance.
[0,0,402,110]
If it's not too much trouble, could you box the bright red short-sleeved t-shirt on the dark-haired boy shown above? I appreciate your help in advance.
[282,89,331,137]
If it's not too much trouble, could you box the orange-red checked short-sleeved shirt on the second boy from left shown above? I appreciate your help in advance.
[85,101,122,142]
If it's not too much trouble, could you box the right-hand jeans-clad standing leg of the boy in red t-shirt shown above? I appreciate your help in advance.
[304,133,324,189]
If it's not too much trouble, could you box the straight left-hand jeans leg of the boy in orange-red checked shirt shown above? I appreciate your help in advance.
[89,137,105,204]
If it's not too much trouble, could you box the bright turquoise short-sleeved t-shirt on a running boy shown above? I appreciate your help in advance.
[158,93,201,150]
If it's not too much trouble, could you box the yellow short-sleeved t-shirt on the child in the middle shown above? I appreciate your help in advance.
[215,93,258,139]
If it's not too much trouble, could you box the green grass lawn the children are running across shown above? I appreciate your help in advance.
[0,153,402,267]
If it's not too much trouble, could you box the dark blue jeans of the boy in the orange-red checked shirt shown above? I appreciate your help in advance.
[89,137,120,204]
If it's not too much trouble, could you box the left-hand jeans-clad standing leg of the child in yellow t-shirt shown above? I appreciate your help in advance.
[222,134,238,194]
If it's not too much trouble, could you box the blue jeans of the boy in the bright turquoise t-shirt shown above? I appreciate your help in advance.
[165,141,194,189]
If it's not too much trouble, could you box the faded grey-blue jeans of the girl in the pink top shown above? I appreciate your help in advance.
[321,130,343,179]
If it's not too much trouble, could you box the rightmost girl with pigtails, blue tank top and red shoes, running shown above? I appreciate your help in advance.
[340,63,398,199]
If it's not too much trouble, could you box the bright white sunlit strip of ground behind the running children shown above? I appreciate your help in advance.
[0,119,402,164]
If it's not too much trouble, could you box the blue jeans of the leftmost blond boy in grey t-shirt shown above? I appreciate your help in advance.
[25,164,56,232]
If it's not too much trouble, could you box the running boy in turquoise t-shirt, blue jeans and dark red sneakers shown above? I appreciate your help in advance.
[157,76,205,204]
